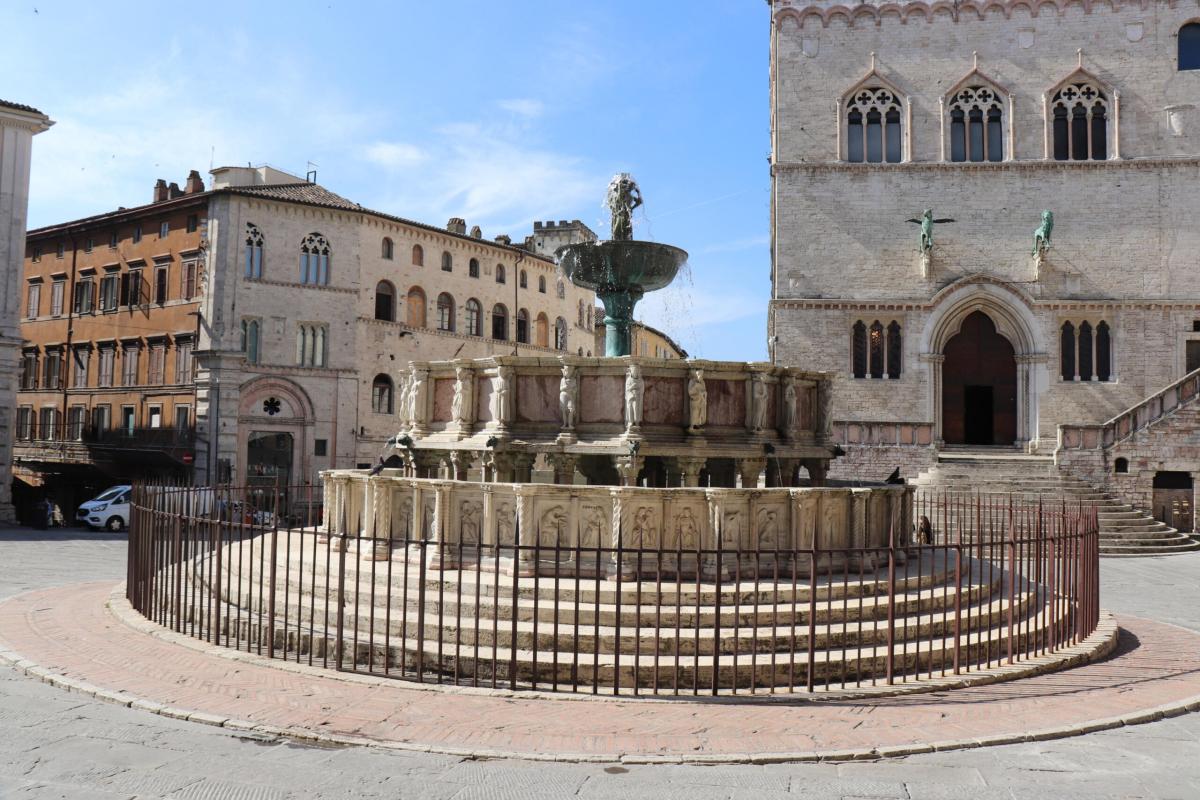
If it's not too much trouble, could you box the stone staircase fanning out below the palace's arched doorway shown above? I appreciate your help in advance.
[916,447,1200,557]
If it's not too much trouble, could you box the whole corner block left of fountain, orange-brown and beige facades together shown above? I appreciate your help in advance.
[12,167,595,509]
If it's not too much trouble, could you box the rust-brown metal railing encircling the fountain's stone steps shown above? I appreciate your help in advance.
[127,486,1099,696]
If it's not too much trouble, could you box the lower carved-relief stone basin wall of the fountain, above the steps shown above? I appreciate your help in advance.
[323,470,912,573]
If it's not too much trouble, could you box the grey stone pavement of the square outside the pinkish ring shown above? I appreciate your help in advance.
[0,531,1200,800]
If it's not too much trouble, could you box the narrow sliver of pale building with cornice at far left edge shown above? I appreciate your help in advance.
[0,100,53,523]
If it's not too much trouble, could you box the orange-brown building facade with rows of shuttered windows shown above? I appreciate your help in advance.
[14,170,209,510]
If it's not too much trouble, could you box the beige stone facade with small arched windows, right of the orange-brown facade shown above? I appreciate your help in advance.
[196,167,595,486]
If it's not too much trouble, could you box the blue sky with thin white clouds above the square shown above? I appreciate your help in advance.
[0,0,770,360]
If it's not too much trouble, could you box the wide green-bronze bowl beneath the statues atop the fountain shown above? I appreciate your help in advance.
[558,240,688,298]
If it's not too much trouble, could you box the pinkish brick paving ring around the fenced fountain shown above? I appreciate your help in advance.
[0,582,1200,763]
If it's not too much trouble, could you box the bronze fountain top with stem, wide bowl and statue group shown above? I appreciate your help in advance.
[558,173,688,357]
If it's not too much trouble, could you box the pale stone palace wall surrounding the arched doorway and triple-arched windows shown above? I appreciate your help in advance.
[769,0,1200,443]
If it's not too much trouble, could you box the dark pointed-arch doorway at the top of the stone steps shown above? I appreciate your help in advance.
[942,311,1016,445]
